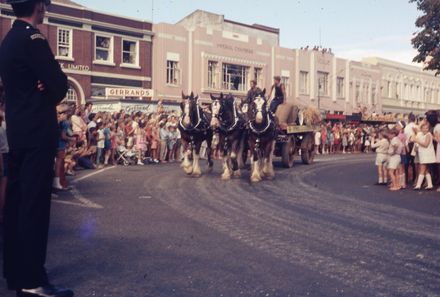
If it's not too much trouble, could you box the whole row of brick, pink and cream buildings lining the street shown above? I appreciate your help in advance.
[0,0,440,115]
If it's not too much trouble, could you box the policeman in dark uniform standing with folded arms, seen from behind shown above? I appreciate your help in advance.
[0,0,73,297]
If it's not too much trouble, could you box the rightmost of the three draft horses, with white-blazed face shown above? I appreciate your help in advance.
[247,89,277,183]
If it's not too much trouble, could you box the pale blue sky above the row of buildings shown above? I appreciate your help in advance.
[73,0,420,64]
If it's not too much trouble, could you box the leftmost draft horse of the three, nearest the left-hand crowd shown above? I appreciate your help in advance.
[179,92,214,177]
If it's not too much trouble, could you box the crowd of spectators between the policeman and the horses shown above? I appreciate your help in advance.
[53,104,180,190]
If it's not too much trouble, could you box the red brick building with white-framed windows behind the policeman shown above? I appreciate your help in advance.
[0,0,153,104]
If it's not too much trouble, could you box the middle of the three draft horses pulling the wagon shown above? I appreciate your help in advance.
[211,93,246,180]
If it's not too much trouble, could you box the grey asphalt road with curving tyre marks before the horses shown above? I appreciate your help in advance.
[0,155,440,297]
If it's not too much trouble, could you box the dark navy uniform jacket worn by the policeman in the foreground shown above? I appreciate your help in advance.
[0,20,68,150]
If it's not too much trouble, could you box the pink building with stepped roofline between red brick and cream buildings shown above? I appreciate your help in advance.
[153,10,390,114]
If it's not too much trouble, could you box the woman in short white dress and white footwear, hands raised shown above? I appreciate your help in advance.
[414,123,437,190]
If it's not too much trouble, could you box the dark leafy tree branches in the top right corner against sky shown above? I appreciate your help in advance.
[409,0,440,75]
